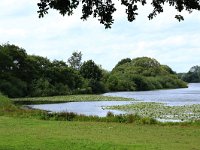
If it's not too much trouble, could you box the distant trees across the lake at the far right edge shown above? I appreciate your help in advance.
[179,66,200,83]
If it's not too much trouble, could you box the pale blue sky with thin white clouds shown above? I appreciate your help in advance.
[0,0,200,72]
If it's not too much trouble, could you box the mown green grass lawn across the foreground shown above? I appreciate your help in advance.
[0,116,200,150]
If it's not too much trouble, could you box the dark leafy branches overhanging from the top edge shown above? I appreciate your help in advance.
[37,0,200,28]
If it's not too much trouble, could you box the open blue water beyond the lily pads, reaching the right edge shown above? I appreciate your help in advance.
[104,83,200,106]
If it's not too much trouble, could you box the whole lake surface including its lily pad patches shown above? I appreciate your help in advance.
[21,83,200,122]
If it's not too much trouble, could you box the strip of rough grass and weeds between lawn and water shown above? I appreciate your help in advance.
[0,94,200,125]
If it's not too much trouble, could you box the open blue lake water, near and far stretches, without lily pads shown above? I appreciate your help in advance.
[28,83,200,117]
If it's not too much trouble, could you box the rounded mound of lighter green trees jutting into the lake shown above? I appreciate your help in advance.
[108,57,187,91]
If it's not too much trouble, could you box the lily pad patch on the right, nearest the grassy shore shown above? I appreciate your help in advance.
[106,102,200,121]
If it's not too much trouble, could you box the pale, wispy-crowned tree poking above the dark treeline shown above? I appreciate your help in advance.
[68,52,82,70]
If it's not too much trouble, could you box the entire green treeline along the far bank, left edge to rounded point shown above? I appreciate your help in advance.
[0,44,186,97]
